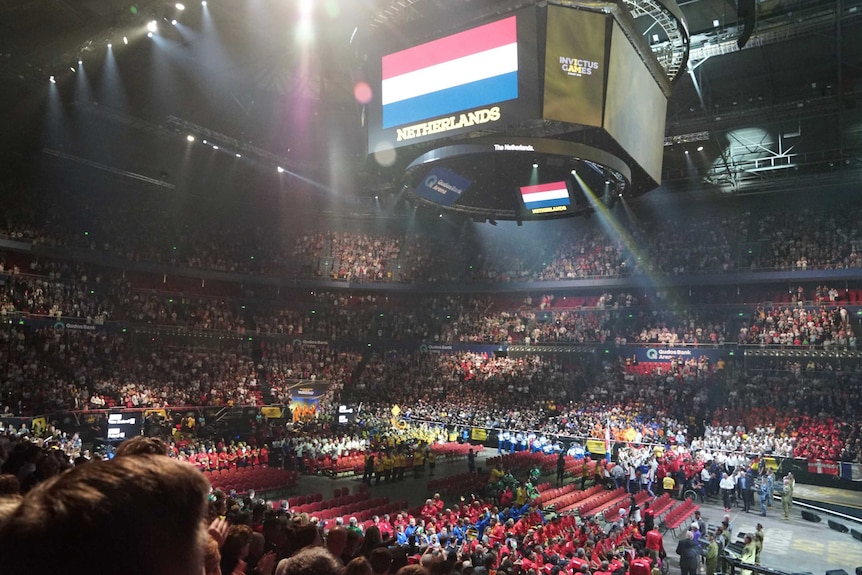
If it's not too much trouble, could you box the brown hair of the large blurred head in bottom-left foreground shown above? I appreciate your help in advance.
[0,455,209,575]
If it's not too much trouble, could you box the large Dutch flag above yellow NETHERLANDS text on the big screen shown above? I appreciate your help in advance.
[380,16,518,128]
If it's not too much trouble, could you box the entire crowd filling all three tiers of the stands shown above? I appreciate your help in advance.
[0,189,860,472]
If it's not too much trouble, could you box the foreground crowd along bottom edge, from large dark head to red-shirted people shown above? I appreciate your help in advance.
[0,430,724,575]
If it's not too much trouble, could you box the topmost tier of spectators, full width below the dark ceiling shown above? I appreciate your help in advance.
[5,183,862,283]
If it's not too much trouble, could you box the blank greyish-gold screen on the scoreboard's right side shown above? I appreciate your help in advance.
[604,22,667,183]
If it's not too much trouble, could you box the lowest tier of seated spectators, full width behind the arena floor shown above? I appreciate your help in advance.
[5,304,862,466]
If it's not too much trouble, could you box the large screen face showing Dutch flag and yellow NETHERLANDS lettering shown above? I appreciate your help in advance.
[368,8,538,153]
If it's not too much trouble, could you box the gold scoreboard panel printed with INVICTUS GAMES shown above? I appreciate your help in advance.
[542,6,610,128]
